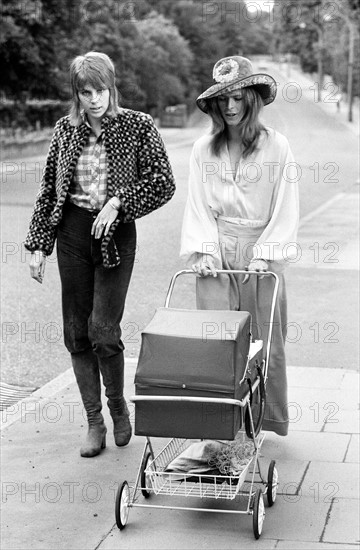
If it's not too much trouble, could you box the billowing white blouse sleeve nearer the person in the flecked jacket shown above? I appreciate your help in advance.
[180,145,221,268]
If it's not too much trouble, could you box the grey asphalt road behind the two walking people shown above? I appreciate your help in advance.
[1,63,359,386]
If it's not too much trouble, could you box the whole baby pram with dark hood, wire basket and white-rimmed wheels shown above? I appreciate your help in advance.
[115,270,279,538]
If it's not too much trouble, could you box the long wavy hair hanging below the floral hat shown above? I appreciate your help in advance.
[207,87,268,158]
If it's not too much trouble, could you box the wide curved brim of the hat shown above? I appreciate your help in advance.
[196,73,277,113]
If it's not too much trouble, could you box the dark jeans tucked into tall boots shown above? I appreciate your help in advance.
[57,202,136,359]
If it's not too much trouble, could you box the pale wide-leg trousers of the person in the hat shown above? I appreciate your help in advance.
[197,219,289,435]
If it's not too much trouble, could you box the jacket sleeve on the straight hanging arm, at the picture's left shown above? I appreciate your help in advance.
[24,122,59,256]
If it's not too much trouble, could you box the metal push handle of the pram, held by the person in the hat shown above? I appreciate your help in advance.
[164,269,279,380]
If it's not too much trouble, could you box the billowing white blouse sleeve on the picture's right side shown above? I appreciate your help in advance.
[254,138,299,264]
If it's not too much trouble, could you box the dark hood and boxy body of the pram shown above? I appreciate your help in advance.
[135,308,261,439]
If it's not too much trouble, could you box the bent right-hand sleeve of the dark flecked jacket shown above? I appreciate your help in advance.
[116,115,175,222]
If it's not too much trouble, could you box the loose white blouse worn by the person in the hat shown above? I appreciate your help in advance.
[180,128,301,267]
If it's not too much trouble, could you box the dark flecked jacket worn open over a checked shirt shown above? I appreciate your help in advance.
[24,109,175,267]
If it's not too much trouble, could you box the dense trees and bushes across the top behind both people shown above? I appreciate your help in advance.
[0,0,359,128]
